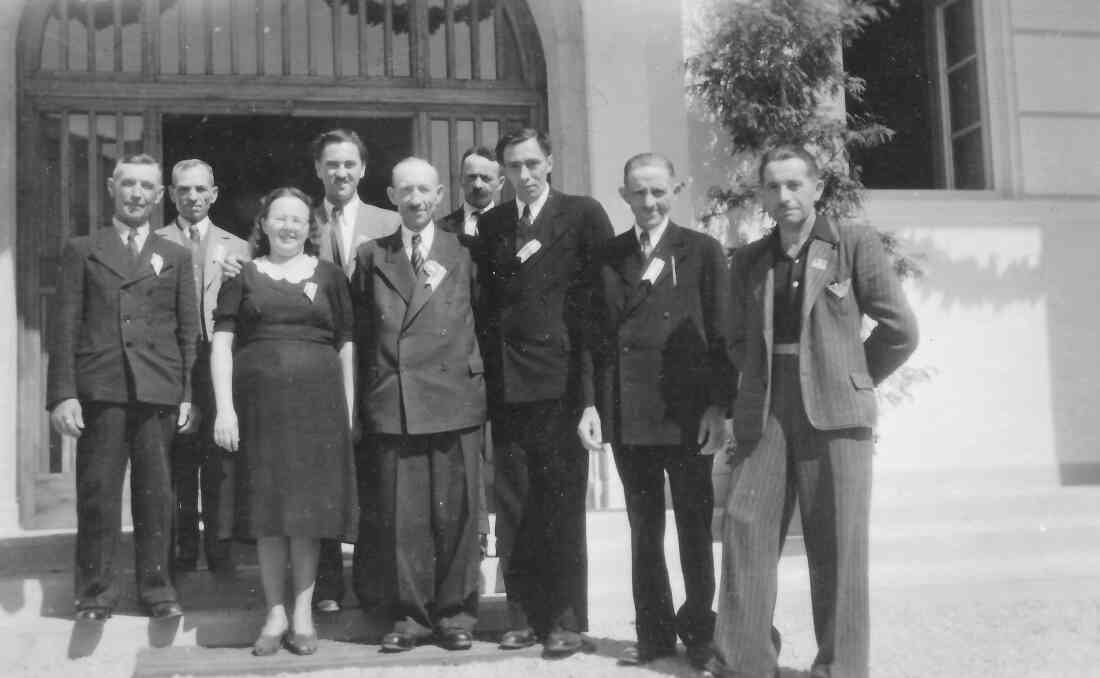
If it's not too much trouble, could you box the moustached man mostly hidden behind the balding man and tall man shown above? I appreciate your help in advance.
[439,146,506,571]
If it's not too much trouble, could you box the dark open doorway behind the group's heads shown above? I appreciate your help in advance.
[162,114,413,238]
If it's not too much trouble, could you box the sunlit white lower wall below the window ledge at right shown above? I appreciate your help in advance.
[868,194,1100,477]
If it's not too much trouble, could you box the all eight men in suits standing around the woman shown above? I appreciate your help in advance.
[48,124,916,677]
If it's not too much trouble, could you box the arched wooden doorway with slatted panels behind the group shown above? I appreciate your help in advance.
[18,0,546,527]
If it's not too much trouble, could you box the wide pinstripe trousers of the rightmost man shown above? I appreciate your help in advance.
[715,356,873,678]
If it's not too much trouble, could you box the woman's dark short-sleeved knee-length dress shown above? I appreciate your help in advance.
[215,261,359,542]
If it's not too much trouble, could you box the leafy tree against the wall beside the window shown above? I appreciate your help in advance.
[685,0,932,404]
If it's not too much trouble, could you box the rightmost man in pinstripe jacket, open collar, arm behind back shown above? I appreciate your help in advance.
[712,146,917,678]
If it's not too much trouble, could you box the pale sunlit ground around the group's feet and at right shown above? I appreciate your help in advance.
[0,477,1100,678]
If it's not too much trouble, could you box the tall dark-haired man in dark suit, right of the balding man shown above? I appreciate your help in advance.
[480,129,613,656]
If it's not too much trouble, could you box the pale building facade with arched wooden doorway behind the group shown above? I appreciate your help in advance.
[0,0,1100,533]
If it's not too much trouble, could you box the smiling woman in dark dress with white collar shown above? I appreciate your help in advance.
[210,188,358,655]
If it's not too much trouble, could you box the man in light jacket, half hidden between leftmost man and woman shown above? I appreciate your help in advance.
[156,158,249,572]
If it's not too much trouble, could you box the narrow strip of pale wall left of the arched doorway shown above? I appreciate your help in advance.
[0,0,23,534]
